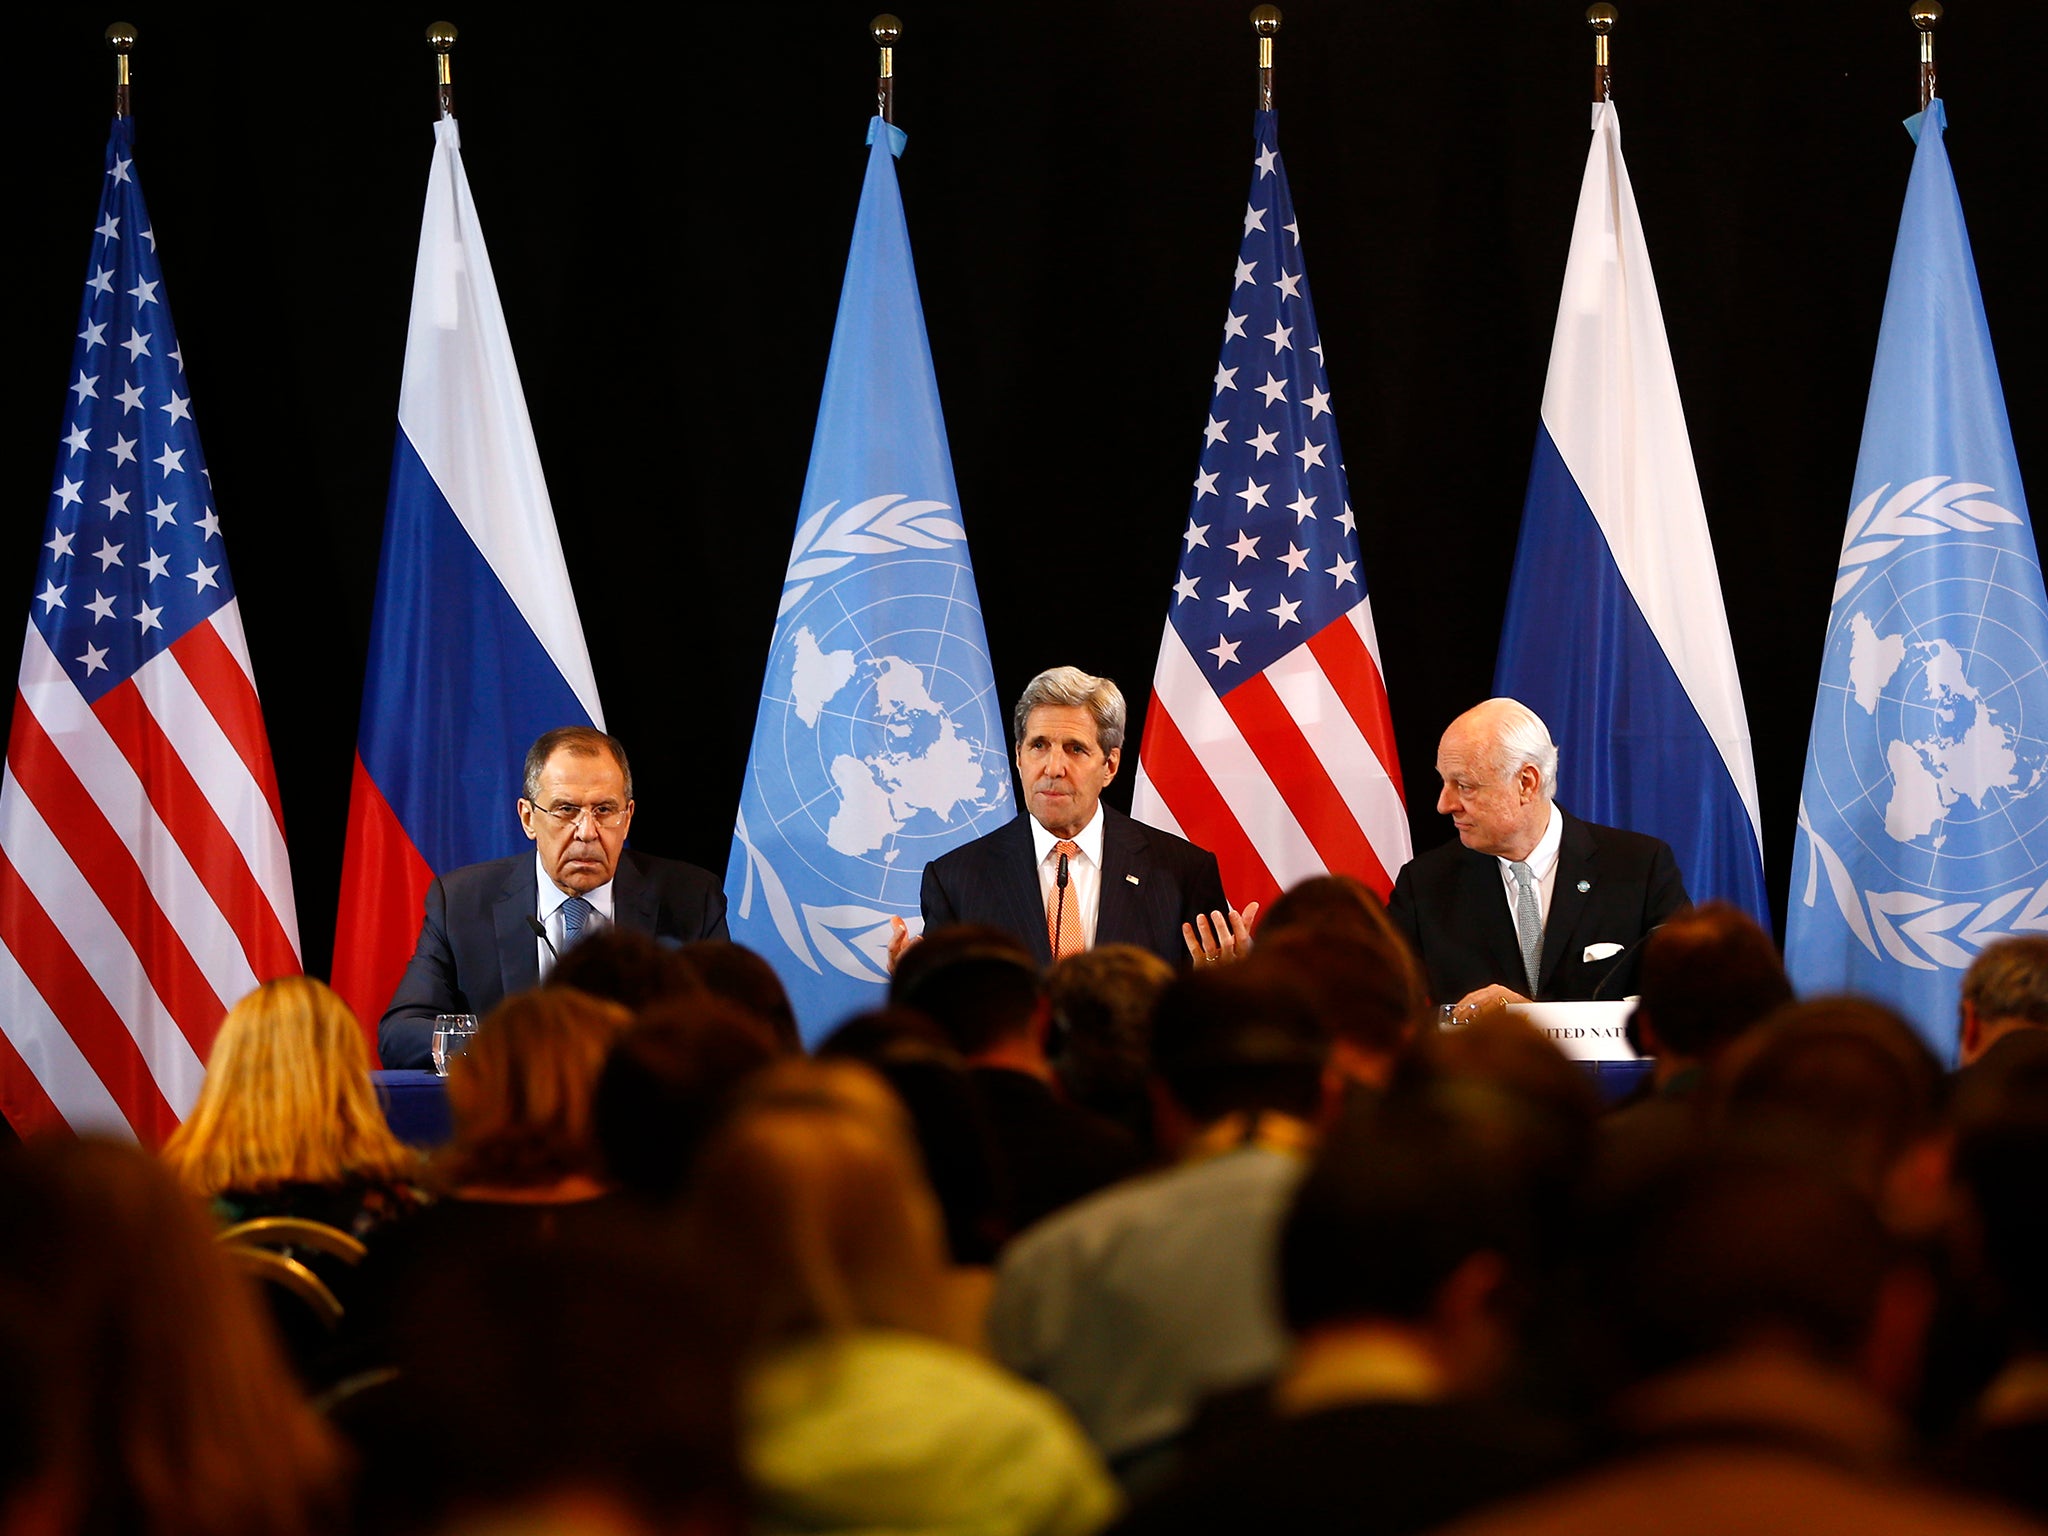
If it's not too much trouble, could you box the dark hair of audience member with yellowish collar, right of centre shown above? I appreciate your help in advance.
[1280,1083,1532,1333]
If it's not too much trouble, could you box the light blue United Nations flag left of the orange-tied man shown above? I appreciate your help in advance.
[725,117,1016,1040]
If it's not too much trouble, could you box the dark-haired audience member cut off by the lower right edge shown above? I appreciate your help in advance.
[1946,1073,2048,1520]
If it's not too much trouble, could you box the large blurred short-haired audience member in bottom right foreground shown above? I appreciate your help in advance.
[1448,1145,2034,1536]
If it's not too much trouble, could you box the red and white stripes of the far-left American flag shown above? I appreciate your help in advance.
[0,602,299,1145]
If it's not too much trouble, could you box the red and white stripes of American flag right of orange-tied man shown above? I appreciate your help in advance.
[1130,602,1413,907]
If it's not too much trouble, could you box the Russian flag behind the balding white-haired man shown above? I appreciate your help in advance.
[1493,102,1769,926]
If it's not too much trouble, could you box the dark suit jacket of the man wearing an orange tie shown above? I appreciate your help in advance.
[922,805,1225,965]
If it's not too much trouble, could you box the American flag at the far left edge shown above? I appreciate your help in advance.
[0,117,299,1145]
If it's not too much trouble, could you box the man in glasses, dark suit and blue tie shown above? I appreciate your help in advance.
[377,725,725,1067]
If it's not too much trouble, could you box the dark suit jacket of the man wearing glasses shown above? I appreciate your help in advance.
[377,848,725,1067]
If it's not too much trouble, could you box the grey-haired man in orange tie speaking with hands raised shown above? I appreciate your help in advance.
[893,668,1257,965]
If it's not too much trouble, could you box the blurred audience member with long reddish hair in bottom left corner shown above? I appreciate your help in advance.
[0,1141,342,1536]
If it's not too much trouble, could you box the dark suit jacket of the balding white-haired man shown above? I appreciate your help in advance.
[1386,811,1692,1004]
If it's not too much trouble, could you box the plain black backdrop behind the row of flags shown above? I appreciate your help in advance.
[0,0,2048,975]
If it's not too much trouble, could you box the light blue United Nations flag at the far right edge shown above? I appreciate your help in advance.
[1786,100,2048,1061]
